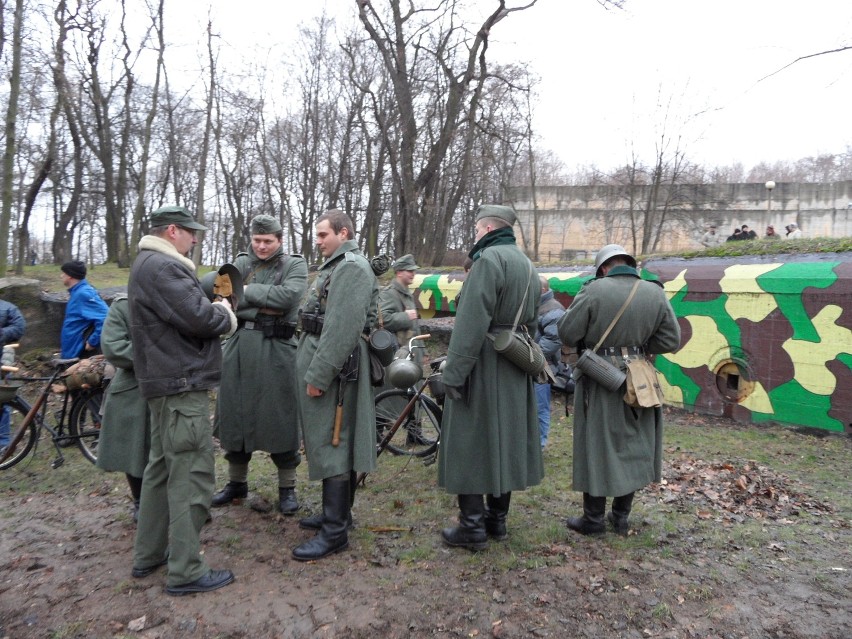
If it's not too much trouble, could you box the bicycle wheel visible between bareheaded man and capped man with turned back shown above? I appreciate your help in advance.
[376,389,441,457]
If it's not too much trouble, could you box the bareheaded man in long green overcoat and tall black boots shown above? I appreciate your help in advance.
[293,210,379,561]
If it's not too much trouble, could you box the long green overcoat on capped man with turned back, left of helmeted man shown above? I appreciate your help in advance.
[438,244,544,495]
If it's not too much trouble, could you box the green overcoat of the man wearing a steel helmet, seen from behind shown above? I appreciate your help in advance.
[558,266,680,497]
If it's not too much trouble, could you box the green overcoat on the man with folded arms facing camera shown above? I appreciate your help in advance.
[215,247,308,453]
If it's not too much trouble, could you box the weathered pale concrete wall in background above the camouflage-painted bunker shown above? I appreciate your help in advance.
[506,181,852,261]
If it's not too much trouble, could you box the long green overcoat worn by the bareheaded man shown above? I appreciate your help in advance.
[296,240,379,480]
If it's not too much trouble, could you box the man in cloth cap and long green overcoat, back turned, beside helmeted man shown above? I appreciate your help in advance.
[438,205,544,550]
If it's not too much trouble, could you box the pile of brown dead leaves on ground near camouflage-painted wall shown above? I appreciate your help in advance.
[649,453,834,522]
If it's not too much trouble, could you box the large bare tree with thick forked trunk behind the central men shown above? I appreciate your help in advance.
[356,0,536,263]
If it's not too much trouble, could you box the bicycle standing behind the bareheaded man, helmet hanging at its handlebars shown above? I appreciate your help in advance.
[375,335,446,460]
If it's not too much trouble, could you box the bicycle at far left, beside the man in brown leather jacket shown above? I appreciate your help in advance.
[0,357,105,470]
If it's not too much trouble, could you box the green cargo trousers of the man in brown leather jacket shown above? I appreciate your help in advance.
[133,390,215,586]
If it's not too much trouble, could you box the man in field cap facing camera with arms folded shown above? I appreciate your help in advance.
[212,215,308,515]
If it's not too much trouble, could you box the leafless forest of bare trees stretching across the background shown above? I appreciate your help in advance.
[0,0,852,272]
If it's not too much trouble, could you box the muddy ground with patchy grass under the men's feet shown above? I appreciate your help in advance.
[0,404,852,639]
